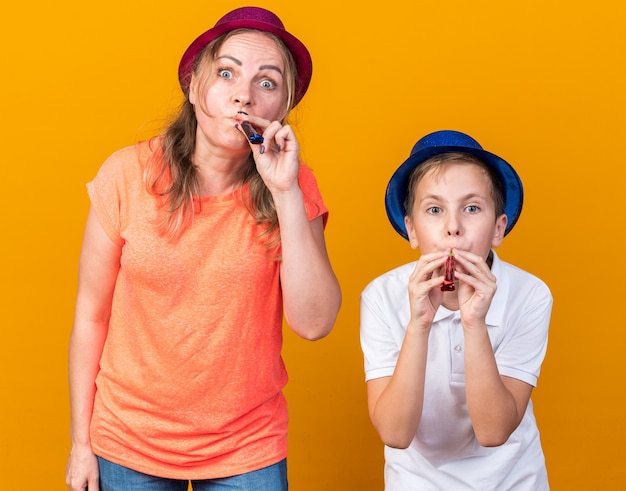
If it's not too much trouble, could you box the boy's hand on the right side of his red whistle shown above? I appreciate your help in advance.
[454,249,496,329]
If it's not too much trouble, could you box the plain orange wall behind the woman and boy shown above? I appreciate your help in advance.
[0,0,626,491]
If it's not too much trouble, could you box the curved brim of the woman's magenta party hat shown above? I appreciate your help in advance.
[178,19,313,106]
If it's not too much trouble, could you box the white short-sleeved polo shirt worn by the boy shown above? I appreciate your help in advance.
[361,252,552,491]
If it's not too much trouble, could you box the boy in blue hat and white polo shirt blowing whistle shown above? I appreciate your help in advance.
[361,131,552,491]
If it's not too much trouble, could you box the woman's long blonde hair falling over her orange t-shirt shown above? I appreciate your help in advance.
[144,29,297,249]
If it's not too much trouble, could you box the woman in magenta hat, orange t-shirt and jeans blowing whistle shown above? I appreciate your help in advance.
[66,7,341,490]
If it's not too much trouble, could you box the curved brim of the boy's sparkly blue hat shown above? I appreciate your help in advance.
[385,145,524,240]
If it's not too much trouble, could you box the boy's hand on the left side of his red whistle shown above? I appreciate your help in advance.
[409,251,449,329]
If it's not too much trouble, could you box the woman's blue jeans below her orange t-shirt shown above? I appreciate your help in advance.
[98,457,288,491]
